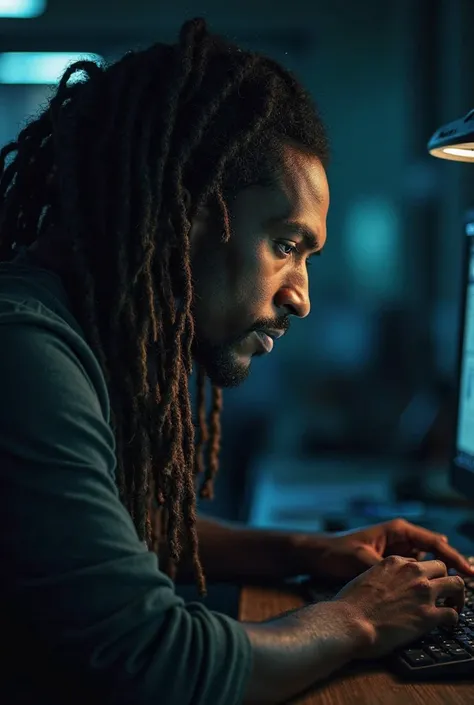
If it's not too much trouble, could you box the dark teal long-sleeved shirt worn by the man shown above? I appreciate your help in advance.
[0,255,251,705]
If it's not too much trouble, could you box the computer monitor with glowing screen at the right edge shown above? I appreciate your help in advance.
[451,210,474,501]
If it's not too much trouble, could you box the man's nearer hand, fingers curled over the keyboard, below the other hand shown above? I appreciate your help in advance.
[336,556,464,659]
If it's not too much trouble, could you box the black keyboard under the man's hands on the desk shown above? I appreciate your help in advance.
[310,558,474,680]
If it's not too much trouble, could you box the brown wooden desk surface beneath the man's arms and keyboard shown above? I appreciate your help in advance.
[239,587,474,705]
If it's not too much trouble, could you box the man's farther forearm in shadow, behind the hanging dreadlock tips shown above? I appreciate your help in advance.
[168,517,330,583]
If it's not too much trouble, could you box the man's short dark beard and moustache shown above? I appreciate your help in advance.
[193,316,290,388]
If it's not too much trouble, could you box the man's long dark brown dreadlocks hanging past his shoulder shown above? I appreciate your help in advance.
[0,20,328,592]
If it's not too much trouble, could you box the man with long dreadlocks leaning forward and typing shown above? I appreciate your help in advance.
[0,20,469,705]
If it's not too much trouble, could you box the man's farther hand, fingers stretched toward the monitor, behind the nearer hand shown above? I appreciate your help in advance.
[294,519,474,581]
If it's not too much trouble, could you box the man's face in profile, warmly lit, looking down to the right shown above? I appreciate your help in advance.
[191,147,329,387]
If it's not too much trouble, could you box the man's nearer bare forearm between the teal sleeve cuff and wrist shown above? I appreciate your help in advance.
[244,602,370,705]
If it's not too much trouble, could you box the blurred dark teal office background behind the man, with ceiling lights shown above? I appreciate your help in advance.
[0,0,474,530]
